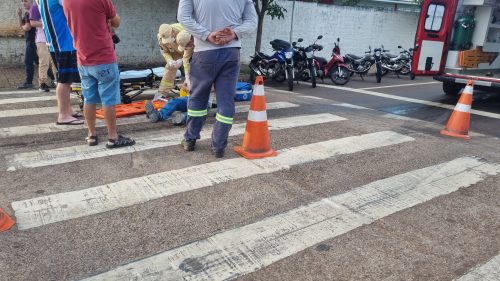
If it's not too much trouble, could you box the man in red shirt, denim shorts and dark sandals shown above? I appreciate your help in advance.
[62,0,135,148]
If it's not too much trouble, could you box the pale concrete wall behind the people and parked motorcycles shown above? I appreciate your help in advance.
[0,0,418,66]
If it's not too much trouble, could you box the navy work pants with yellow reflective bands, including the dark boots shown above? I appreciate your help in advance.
[183,48,240,158]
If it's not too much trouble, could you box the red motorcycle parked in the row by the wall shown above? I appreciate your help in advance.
[314,38,351,85]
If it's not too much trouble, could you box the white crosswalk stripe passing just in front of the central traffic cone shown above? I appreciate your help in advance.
[12,131,414,229]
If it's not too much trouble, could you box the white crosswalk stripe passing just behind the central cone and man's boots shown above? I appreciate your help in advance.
[5,113,346,171]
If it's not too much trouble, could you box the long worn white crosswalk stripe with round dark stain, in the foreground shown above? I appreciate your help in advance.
[80,157,500,281]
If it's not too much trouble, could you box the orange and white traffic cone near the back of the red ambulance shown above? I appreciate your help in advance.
[441,80,474,140]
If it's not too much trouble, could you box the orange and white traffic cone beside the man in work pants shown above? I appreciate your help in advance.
[234,76,278,159]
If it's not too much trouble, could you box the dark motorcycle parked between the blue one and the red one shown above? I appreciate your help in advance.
[292,35,323,88]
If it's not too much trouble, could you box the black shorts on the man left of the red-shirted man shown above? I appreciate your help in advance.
[50,51,80,84]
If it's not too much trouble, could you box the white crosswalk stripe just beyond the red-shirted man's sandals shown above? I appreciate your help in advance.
[0,102,298,138]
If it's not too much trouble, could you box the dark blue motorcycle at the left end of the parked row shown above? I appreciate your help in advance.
[249,39,294,91]
